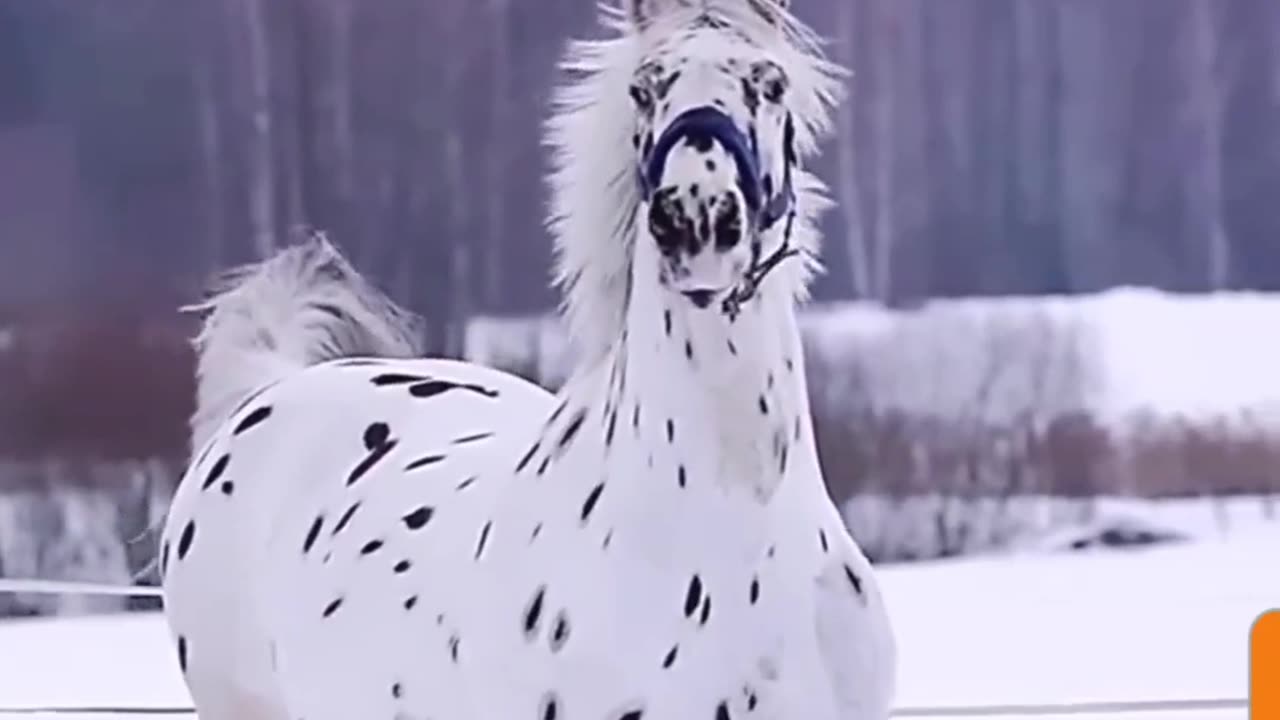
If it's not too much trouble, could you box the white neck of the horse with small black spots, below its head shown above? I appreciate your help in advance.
[537,226,820,571]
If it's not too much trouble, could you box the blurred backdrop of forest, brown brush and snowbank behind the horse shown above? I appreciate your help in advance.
[0,0,1280,615]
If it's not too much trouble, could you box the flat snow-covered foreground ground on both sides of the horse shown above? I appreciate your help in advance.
[0,525,1264,720]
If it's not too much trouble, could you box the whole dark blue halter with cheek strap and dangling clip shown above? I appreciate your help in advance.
[637,105,799,318]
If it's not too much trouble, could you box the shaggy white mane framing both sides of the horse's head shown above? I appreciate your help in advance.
[544,0,846,361]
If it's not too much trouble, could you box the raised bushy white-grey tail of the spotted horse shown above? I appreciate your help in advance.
[183,233,422,451]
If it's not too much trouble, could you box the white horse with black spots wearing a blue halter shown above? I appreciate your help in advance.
[161,0,896,720]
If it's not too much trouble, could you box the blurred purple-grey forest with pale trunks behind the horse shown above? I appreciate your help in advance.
[0,0,1280,354]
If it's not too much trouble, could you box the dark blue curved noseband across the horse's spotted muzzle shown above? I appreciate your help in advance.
[640,105,795,232]
